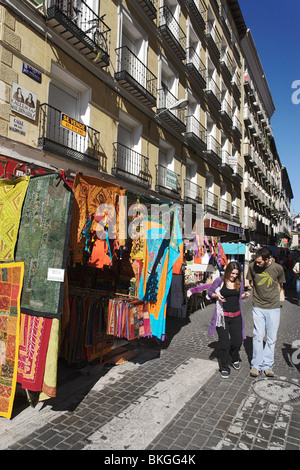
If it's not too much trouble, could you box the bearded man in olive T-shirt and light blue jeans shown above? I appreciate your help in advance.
[247,248,285,377]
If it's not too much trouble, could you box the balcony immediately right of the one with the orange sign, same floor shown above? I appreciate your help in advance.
[112,142,152,188]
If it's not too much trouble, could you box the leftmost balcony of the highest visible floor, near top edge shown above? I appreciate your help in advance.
[159,6,186,60]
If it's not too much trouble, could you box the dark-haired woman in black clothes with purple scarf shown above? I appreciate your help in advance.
[207,261,250,379]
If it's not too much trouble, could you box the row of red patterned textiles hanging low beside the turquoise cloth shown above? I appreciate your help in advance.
[106,298,151,340]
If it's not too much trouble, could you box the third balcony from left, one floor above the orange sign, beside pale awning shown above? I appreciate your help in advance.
[157,88,186,133]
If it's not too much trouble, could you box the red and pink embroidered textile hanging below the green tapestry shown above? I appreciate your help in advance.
[17,313,52,392]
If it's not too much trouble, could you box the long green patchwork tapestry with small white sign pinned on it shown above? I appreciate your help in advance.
[16,174,73,318]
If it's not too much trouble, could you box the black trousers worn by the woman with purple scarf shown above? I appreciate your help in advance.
[217,315,243,371]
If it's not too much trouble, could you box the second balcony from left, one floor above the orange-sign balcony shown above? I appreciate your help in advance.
[115,46,157,108]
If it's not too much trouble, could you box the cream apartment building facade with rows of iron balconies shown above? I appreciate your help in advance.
[0,0,285,241]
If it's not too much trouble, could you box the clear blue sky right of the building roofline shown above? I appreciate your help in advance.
[239,0,300,214]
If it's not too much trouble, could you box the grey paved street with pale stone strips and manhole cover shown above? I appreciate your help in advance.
[0,290,300,451]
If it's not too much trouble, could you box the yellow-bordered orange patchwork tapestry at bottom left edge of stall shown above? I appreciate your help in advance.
[0,263,24,419]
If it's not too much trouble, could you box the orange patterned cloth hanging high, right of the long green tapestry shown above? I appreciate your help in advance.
[70,173,126,263]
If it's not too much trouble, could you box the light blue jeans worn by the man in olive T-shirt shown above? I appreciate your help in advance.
[251,307,280,370]
